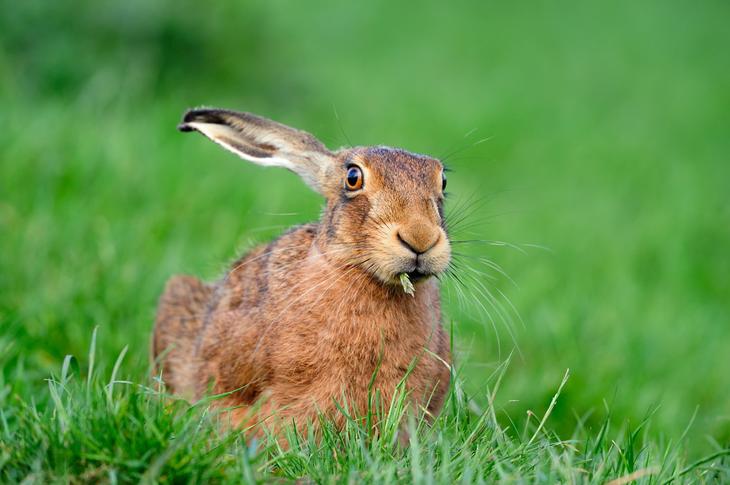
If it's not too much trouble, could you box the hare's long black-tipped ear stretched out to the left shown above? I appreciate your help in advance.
[178,108,335,194]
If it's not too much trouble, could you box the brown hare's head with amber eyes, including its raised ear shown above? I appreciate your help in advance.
[179,109,451,284]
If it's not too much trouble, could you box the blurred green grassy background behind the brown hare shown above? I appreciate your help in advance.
[0,0,730,449]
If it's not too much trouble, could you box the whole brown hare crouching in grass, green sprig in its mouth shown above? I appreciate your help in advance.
[152,109,451,434]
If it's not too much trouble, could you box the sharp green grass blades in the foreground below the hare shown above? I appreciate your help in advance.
[0,334,730,484]
